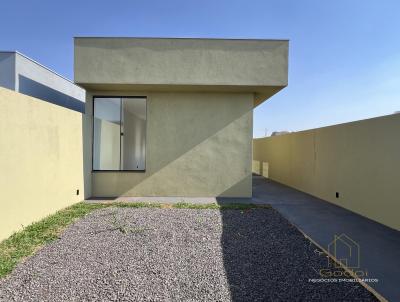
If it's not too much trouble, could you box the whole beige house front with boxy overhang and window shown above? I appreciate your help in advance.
[74,37,288,197]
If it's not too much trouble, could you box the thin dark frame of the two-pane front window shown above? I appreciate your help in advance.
[91,95,148,173]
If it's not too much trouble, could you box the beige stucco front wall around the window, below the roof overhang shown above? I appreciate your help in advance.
[85,91,254,197]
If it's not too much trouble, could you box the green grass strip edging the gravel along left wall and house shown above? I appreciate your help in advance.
[0,202,269,278]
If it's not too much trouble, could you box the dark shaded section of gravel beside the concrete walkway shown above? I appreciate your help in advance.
[217,209,377,301]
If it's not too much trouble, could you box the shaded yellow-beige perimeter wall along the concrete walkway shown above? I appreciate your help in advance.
[253,114,400,230]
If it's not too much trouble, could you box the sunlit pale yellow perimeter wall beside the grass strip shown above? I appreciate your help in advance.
[0,88,84,240]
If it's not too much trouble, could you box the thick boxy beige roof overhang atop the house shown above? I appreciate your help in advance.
[74,38,288,106]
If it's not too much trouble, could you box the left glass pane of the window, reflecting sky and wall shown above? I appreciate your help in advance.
[93,98,121,170]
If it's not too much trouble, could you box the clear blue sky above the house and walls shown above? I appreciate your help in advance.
[0,0,400,137]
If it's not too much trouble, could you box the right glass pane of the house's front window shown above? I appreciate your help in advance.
[121,98,146,170]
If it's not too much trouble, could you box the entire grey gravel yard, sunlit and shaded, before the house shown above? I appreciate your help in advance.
[0,208,376,301]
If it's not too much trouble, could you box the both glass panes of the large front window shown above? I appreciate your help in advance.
[93,97,146,171]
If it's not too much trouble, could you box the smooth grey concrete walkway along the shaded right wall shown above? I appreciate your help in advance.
[252,176,400,301]
